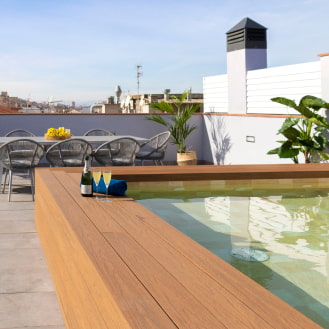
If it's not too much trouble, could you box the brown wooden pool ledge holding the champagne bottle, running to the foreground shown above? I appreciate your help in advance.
[35,166,320,329]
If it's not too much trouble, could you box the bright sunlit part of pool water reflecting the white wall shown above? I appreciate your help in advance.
[203,197,329,306]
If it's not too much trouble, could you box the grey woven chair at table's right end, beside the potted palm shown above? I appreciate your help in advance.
[136,131,170,165]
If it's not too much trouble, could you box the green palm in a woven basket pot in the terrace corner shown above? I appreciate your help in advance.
[146,91,201,165]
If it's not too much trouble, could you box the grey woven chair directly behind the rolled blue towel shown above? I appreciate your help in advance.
[94,137,140,166]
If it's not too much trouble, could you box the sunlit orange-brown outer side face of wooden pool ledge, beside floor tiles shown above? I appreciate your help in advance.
[36,170,133,329]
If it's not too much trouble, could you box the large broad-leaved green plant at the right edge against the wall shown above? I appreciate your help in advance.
[267,95,329,163]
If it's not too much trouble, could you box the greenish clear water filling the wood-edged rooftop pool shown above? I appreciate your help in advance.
[128,179,329,328]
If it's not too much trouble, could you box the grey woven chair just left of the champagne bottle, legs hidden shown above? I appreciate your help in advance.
[46,138,92,167]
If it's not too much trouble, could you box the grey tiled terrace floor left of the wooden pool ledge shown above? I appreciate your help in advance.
[0,175,65,329]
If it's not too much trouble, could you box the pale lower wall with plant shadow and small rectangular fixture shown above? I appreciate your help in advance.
[204,115,292,165]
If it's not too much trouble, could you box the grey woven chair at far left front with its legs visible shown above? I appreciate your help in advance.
[0,139,44,201]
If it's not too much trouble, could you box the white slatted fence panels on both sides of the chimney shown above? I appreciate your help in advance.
[203,61,325,114]
